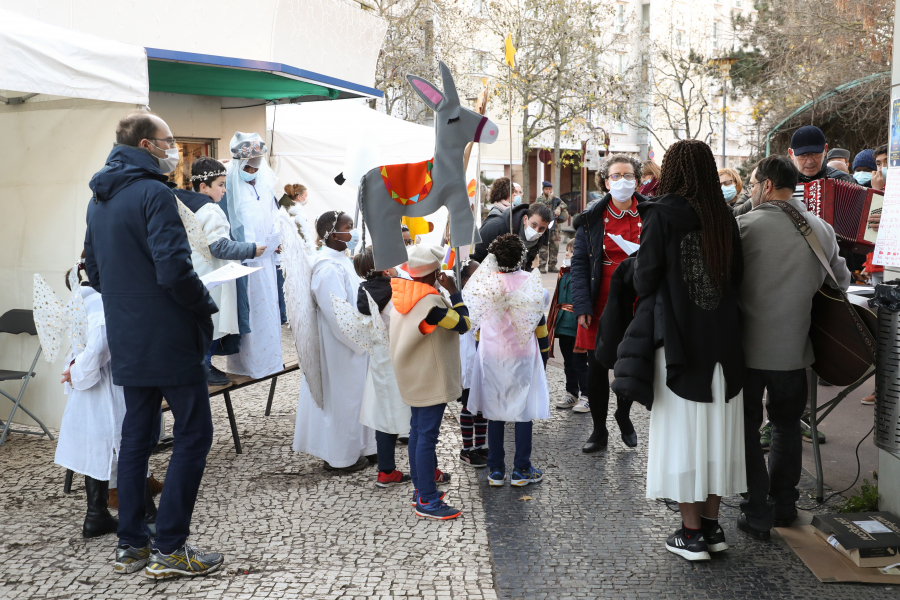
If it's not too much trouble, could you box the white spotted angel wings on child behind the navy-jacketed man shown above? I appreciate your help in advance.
[33,269,87,363]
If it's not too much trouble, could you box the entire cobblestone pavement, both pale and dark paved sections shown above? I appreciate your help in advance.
[0,328,897,600]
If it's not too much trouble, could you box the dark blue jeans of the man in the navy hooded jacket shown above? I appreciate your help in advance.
[118,381,213,554]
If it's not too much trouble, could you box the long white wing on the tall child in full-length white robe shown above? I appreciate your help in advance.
[278,208,325,408]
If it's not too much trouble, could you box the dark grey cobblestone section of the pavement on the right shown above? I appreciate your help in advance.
[480,367,900,600]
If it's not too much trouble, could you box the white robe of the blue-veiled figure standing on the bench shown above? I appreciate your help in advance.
[228,181,284,379]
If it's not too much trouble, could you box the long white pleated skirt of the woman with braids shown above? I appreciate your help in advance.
[647,348,747,503]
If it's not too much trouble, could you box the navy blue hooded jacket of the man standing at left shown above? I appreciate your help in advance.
[84,146,219,387]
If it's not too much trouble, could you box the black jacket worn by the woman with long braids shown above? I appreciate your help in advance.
[619,194,744,402]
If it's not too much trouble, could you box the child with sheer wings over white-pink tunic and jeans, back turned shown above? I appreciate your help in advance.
[464,234,550,486]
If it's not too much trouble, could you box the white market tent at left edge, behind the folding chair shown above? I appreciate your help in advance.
[0,10,149,436]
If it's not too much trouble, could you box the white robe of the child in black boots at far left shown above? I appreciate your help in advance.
[54,288,125,481]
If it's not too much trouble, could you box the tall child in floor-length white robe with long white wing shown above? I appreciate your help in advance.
[280,211,376,472]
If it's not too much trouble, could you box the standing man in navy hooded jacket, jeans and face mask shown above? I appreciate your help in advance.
[84,112,223,578]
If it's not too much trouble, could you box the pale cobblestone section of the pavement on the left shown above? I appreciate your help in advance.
[0,330,497,600]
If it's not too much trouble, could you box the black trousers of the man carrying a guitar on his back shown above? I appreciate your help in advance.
[741,369,807,530]
